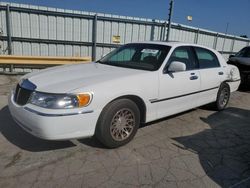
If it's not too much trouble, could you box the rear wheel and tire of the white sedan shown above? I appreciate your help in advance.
[214,83,230,111]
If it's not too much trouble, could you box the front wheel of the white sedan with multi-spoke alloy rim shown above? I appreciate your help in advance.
[95,99,140,148]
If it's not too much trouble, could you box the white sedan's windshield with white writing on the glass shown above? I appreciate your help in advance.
[97,43,171,71]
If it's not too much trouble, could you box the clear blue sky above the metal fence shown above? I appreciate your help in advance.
[5,0,250,38]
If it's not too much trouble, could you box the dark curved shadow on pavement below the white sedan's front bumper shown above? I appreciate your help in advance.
[0,106,75,152]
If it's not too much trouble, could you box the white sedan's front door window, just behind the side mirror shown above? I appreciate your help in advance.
[168,46,197,70]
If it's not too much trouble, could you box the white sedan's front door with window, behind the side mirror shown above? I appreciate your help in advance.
[156,46,200,118]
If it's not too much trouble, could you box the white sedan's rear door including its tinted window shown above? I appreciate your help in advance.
[194,47,225,105]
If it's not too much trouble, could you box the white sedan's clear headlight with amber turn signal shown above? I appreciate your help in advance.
[29,92,92,109]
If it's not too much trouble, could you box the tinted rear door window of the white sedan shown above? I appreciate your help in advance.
[194,47,220,69]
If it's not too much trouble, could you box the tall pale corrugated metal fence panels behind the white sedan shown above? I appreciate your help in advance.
[0,2,249,59]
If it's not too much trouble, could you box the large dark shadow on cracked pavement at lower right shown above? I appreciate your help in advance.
[173,107,250,187]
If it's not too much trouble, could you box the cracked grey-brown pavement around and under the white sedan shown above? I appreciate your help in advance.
[0,75,250,188]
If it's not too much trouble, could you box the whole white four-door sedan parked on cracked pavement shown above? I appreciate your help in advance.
[9,42,240,148]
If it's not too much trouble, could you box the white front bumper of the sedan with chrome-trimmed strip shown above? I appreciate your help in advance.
[9,93,99,140]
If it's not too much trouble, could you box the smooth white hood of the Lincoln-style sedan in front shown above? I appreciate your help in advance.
[23,63,145,93]
